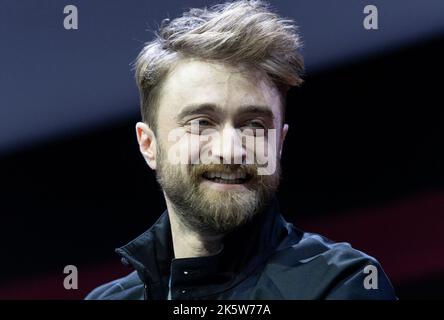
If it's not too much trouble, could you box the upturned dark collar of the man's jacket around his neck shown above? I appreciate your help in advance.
[116,198,291,299]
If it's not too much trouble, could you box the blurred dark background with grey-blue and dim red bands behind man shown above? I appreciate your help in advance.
[0,0,444,299]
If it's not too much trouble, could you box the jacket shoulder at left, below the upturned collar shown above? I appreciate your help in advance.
[85,271,144,300]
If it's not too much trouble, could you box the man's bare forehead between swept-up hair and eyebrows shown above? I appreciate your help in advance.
[159,60,281,116]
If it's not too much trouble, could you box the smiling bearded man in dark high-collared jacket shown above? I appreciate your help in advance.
[87,1,395,300]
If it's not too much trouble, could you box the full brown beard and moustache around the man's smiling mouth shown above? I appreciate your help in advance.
[156,145,280,235]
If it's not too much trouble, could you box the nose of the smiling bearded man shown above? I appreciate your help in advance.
[212,125,246,164]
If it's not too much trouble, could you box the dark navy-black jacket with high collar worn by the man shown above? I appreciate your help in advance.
[86,201,396,300]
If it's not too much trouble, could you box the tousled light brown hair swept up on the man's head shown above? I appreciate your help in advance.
[135,0,304,130]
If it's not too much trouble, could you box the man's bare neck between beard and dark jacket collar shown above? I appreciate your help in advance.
[165,197,223,259]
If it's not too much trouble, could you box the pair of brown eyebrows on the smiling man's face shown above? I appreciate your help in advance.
[176,103,275,120]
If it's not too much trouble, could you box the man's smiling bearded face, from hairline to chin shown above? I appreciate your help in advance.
[139,60,287,233]
